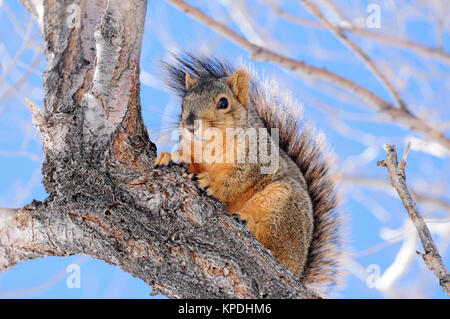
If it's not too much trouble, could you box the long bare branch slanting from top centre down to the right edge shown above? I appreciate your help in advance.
[166,0,450,150]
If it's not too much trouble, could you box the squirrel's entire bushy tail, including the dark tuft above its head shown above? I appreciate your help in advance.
[163,53,342,291]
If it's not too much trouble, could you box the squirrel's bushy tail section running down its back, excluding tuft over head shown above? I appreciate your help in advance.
[252,81,342,291]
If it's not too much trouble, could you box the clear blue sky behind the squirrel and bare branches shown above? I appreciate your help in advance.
[0,0,450,298]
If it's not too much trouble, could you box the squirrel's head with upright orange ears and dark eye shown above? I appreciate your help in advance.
[180,70,250,133]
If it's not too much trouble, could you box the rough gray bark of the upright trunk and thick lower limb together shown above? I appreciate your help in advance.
[0,0,317,298]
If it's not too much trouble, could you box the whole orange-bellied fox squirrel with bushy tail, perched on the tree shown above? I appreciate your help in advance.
[155,53,341,290]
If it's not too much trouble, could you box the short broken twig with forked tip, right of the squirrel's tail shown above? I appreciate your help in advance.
[378,144,450,295]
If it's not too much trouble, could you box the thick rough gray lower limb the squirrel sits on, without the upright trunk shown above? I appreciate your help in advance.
[0,168,318,298]
